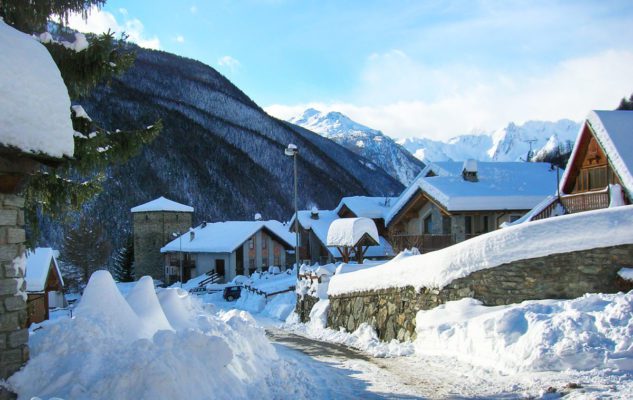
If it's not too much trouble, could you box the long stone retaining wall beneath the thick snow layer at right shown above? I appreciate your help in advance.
[328,245,633,341]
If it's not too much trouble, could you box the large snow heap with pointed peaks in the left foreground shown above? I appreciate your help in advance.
[9,271,314,399]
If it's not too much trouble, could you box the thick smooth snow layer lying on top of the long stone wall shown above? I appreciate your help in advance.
[328,205,633,296]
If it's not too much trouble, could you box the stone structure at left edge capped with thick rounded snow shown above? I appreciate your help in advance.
[0,20,74,390]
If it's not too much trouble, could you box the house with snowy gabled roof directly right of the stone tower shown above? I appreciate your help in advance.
[160,220,295,283]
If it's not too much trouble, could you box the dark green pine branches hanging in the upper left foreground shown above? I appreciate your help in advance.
[0,0,162,242]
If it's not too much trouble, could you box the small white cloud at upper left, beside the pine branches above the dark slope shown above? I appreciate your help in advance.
[62,7,160,49]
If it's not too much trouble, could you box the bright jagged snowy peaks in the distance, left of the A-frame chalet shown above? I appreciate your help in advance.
[398,119,580,161]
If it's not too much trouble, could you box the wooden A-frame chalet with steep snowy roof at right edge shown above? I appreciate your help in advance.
[518,111,633,222]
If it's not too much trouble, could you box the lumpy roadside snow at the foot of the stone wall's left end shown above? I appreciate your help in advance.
[283,299,414,357]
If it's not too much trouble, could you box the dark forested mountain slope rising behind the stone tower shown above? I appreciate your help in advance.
[37,49,403,252]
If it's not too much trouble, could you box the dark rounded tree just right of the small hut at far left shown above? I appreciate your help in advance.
[61,218,112,287]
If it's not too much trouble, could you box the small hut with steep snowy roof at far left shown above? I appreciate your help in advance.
[26,247,67,325]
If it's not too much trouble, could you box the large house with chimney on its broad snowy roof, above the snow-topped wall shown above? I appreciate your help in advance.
[385,160,558,252]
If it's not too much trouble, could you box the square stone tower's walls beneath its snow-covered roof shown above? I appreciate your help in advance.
[132,212,192,282]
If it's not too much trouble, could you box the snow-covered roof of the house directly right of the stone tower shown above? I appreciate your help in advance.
[160,220,295,253]
